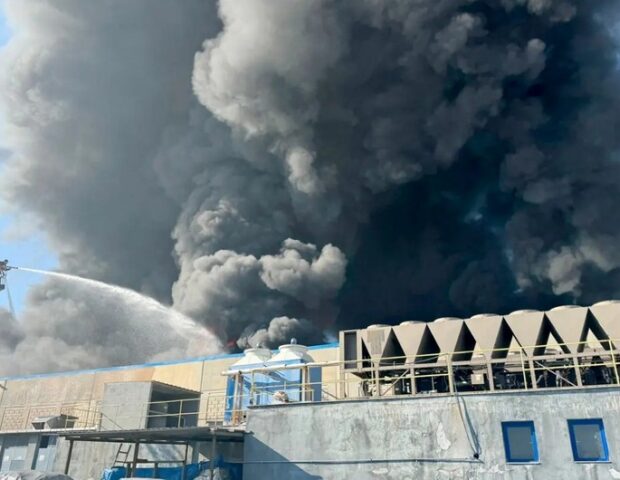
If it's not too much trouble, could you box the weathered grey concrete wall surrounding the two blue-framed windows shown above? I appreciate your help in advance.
[244,388,620,480]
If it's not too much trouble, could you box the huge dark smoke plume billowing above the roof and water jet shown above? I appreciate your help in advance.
[0,0,620,376]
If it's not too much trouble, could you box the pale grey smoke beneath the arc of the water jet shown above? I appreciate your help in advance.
[0,281,222,375]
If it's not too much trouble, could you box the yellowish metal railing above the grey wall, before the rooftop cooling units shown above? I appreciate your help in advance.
[224,340,620,418]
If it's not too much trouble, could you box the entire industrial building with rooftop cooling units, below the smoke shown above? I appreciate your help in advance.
[0,301,620,480]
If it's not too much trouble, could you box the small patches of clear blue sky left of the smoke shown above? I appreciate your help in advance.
[0,1,56,316]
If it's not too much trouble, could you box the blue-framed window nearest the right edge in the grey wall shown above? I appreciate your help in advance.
[568,418,609,462]
